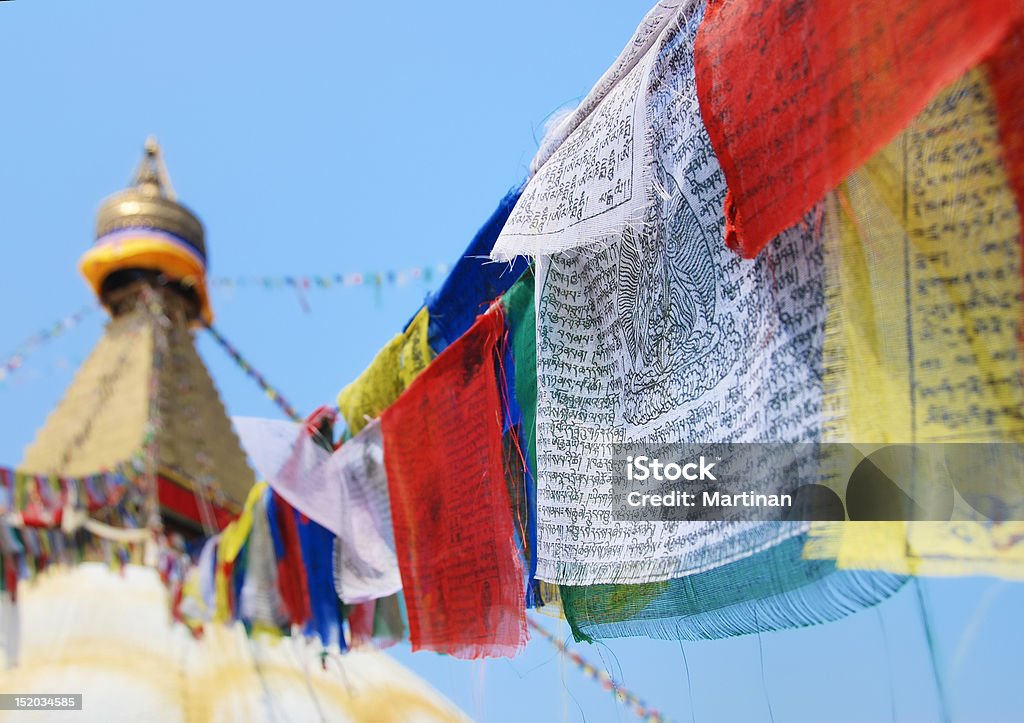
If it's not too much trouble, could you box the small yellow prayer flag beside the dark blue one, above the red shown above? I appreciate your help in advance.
[338,307,433,434]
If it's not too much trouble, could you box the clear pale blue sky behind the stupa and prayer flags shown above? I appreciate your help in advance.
[0,0,1024,722]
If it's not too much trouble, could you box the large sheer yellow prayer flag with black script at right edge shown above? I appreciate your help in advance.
[804,70,1024,579]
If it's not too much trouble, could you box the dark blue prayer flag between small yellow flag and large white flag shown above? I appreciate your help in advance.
[426,187,526,353]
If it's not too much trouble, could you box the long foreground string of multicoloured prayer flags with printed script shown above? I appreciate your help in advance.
[28,0,1024,659]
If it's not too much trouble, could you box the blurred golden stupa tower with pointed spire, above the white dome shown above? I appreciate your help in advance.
[19,138,254,537]
